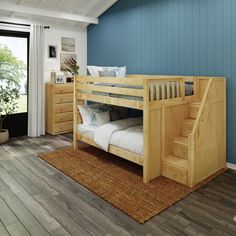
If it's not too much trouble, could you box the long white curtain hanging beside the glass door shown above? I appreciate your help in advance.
[28,25,45,137]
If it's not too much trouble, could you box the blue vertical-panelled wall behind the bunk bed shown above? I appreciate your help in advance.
[88,0,236,164]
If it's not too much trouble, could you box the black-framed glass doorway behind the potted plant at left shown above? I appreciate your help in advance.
[0,30,29,137]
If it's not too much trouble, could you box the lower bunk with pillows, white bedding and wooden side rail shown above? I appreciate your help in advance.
[77,106,143,165]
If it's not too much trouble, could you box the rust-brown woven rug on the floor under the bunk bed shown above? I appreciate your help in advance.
[39,145,225,223]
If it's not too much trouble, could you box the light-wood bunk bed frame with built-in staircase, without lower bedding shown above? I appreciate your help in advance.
[74,75,226,187]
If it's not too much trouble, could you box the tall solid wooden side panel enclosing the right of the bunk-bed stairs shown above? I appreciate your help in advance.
[189,78,226,186]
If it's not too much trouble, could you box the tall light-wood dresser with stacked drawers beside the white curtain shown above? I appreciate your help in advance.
[46,83,73,135]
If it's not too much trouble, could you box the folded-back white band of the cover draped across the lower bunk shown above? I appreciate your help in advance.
[94,118,143,151]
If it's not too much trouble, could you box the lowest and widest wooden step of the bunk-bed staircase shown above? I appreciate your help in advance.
[162,156,188,184]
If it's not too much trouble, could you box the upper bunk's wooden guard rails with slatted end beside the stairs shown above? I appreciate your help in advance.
[75,75,197,110]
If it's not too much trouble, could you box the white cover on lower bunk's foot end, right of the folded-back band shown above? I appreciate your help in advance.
[110,125,143,155]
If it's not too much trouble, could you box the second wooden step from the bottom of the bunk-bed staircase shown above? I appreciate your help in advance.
[173,136,188,159]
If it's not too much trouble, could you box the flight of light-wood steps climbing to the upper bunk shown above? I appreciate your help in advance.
[162,103,200,185]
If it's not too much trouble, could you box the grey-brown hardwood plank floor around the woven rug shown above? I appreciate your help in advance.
[0,134,236,236]
